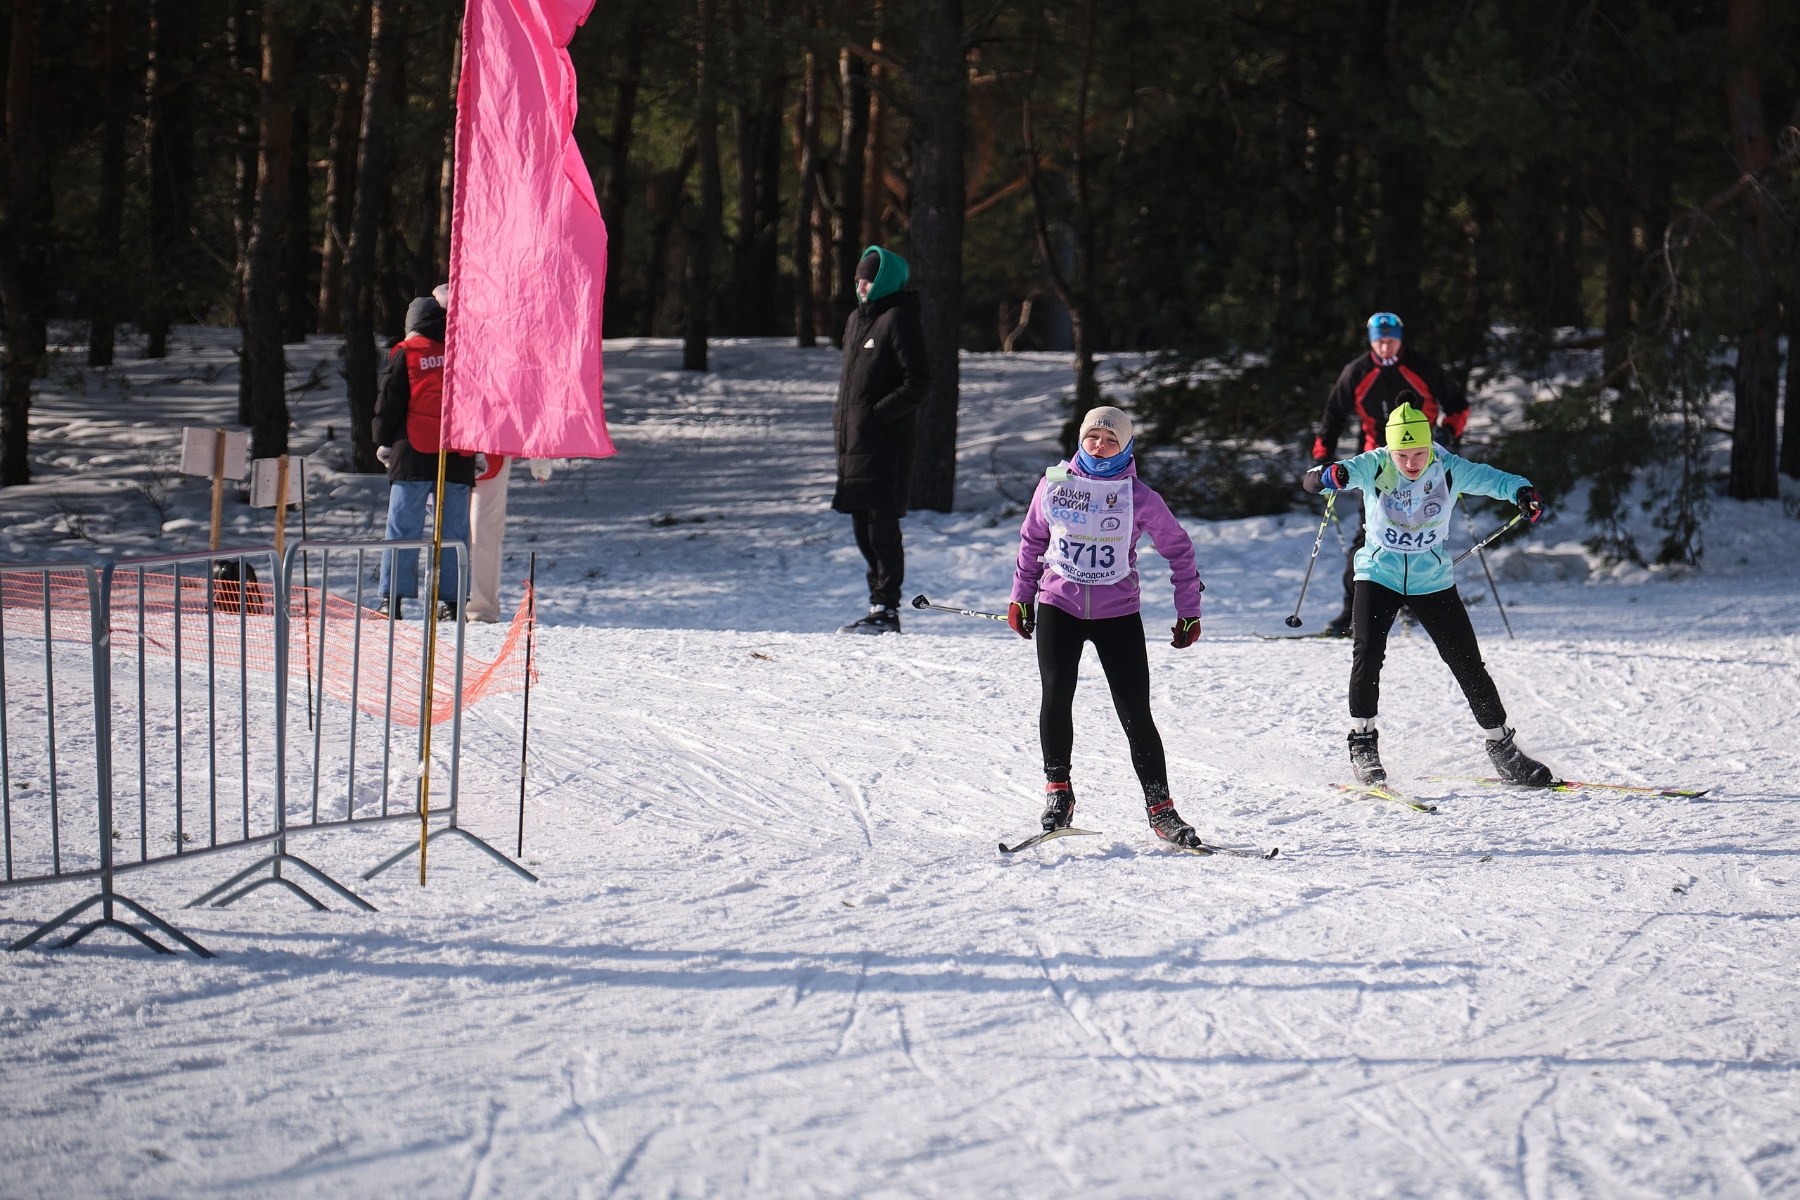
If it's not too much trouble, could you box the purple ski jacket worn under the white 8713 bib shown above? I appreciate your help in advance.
[1012,461,1202,621]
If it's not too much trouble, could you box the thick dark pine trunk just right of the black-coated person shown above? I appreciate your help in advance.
[909,0,968,513]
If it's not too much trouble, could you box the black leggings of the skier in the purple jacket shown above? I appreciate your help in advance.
[1035,604,1168,792]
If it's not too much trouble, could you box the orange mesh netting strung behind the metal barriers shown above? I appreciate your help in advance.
[0,563,536,725]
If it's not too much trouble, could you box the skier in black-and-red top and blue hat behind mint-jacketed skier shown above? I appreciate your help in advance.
[1312,313,1469,637]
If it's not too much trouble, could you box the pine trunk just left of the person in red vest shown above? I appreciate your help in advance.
[338,0,401,471]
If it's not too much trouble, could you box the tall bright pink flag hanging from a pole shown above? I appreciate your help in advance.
[443,0,614,459]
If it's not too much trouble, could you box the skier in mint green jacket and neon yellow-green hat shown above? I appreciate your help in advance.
[1301,403,1555,788]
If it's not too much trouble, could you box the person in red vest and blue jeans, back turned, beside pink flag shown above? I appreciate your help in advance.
[374,295,475,621]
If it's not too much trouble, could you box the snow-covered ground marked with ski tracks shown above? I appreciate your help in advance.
[0,331,1800,1196]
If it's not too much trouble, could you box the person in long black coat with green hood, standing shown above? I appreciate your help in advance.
[832,246,931,633]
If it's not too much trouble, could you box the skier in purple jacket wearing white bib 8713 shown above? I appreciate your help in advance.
[1006,407,1204,847]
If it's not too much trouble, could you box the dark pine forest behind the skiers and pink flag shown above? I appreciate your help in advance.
[0,0,1800,561]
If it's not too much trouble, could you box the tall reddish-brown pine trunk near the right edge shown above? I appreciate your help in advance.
[1724,0,1780,500]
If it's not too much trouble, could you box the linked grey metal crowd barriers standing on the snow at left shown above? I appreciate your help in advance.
[0,540,536,954]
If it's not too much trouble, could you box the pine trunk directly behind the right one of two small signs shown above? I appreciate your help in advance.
[243,9,293,459]
